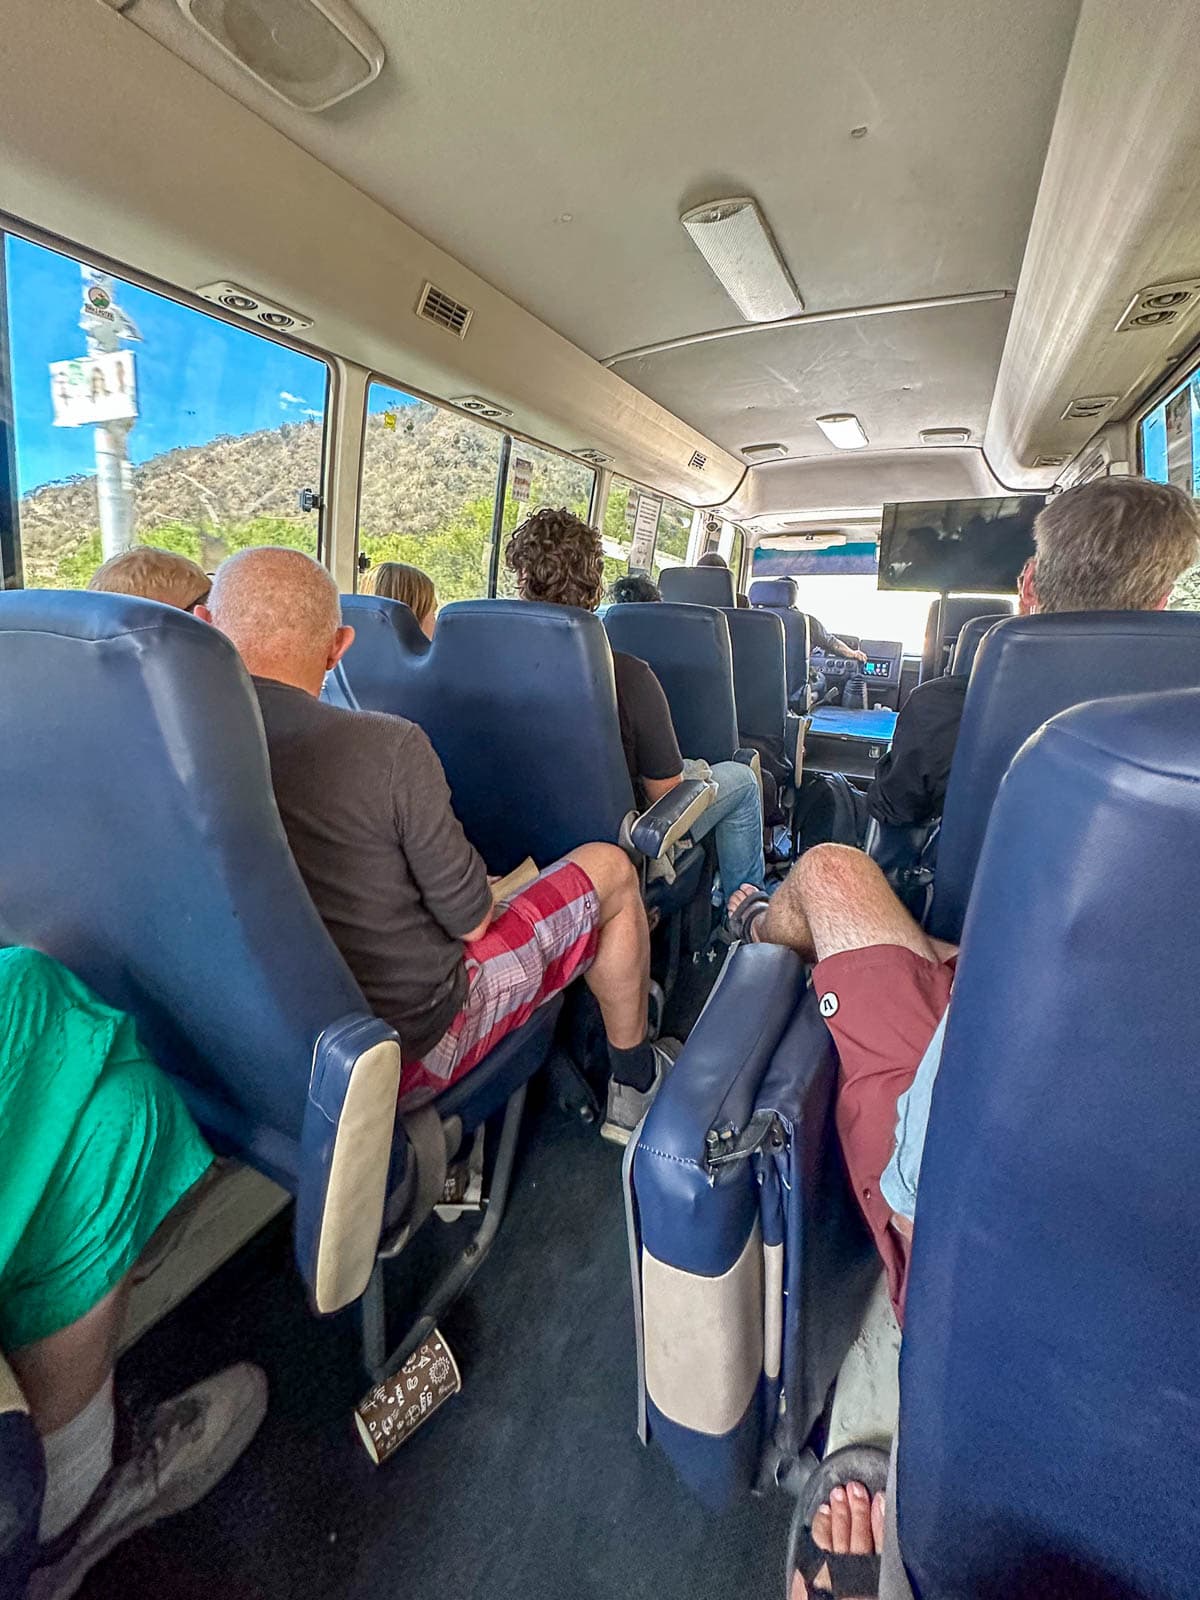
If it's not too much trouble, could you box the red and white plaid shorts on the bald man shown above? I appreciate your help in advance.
[400,861,600,1110]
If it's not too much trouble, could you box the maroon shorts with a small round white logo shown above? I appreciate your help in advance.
[813,944,955,1314]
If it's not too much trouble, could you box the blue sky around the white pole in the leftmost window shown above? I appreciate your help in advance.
[6,235,334,494]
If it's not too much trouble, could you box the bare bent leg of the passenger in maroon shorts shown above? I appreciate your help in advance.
[758,845,954,962]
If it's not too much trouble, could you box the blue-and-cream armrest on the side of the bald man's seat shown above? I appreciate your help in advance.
[296,1013,400,1312]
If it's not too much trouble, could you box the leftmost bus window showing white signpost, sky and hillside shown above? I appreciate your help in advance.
[3,234,328,589]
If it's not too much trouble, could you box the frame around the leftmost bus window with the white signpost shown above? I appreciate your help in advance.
[0,211,341,589]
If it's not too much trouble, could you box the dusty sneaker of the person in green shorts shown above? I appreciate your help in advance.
[27,1362,267,1600]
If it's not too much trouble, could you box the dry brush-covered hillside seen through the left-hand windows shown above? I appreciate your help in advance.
[21,403,640,602]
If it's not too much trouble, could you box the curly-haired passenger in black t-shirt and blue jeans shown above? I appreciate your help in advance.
[504,507,766,901]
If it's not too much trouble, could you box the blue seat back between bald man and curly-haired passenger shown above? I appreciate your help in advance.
[342,595,633,872]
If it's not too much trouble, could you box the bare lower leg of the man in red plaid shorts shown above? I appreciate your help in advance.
[566,845,650,1050]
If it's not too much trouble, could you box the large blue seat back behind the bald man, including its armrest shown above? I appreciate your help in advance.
[0,589,400,1307]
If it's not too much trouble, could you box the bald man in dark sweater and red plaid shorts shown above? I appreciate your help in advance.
[197,549,670,1138]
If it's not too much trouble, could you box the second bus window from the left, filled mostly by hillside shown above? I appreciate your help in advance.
[358,382,504,605]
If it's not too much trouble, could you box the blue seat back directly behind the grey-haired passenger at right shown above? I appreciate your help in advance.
[928,611,1200,942]
